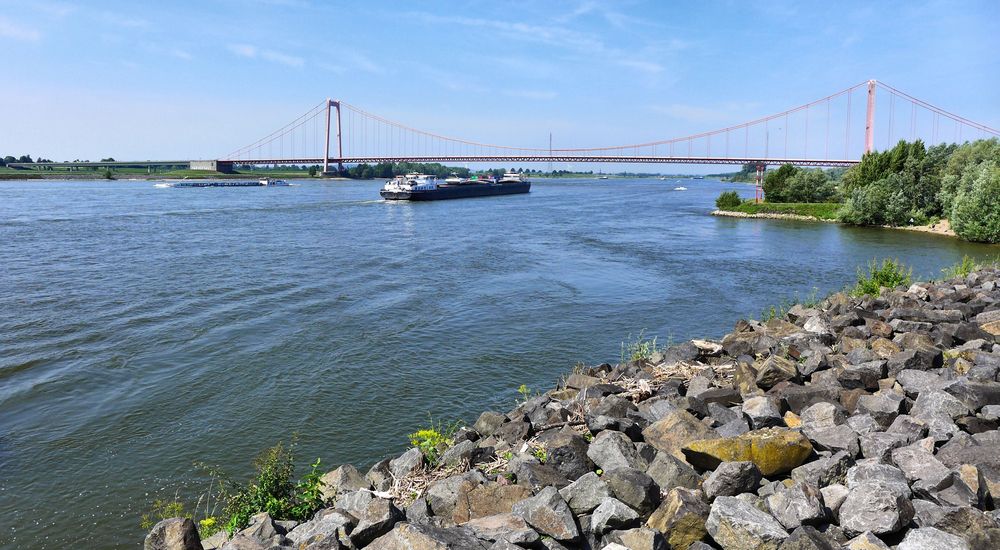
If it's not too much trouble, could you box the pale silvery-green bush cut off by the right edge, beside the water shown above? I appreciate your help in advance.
[951,161,1000,243]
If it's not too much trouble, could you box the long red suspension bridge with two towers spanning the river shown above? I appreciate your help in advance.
[219,80,1000,173]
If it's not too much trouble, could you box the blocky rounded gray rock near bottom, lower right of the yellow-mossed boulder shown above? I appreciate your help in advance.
[840,481,913,536]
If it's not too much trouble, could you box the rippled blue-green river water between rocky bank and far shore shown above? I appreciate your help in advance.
[0,179,1000,549]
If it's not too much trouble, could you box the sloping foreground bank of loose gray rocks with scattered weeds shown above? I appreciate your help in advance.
[144,258,1000,550]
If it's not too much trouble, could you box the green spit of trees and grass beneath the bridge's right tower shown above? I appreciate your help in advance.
[716,138,1000,243]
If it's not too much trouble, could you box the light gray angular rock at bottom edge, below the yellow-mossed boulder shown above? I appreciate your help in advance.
[705,497,788,550]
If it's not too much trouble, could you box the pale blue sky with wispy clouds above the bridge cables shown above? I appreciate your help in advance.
[0,0,1000,172]
